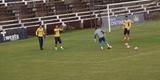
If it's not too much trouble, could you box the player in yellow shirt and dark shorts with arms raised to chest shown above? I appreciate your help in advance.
[54,25,64,50]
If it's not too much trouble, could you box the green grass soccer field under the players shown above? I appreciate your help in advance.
[0,21,160,80]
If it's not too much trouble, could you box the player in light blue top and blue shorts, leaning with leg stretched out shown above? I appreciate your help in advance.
[94,27,112,50]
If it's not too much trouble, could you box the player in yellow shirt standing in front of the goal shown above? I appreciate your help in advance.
[123,16,131,42]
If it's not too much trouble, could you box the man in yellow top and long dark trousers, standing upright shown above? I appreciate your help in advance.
[36,25,45,50]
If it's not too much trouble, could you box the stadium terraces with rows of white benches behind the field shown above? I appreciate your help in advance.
[0,0,160,33]
